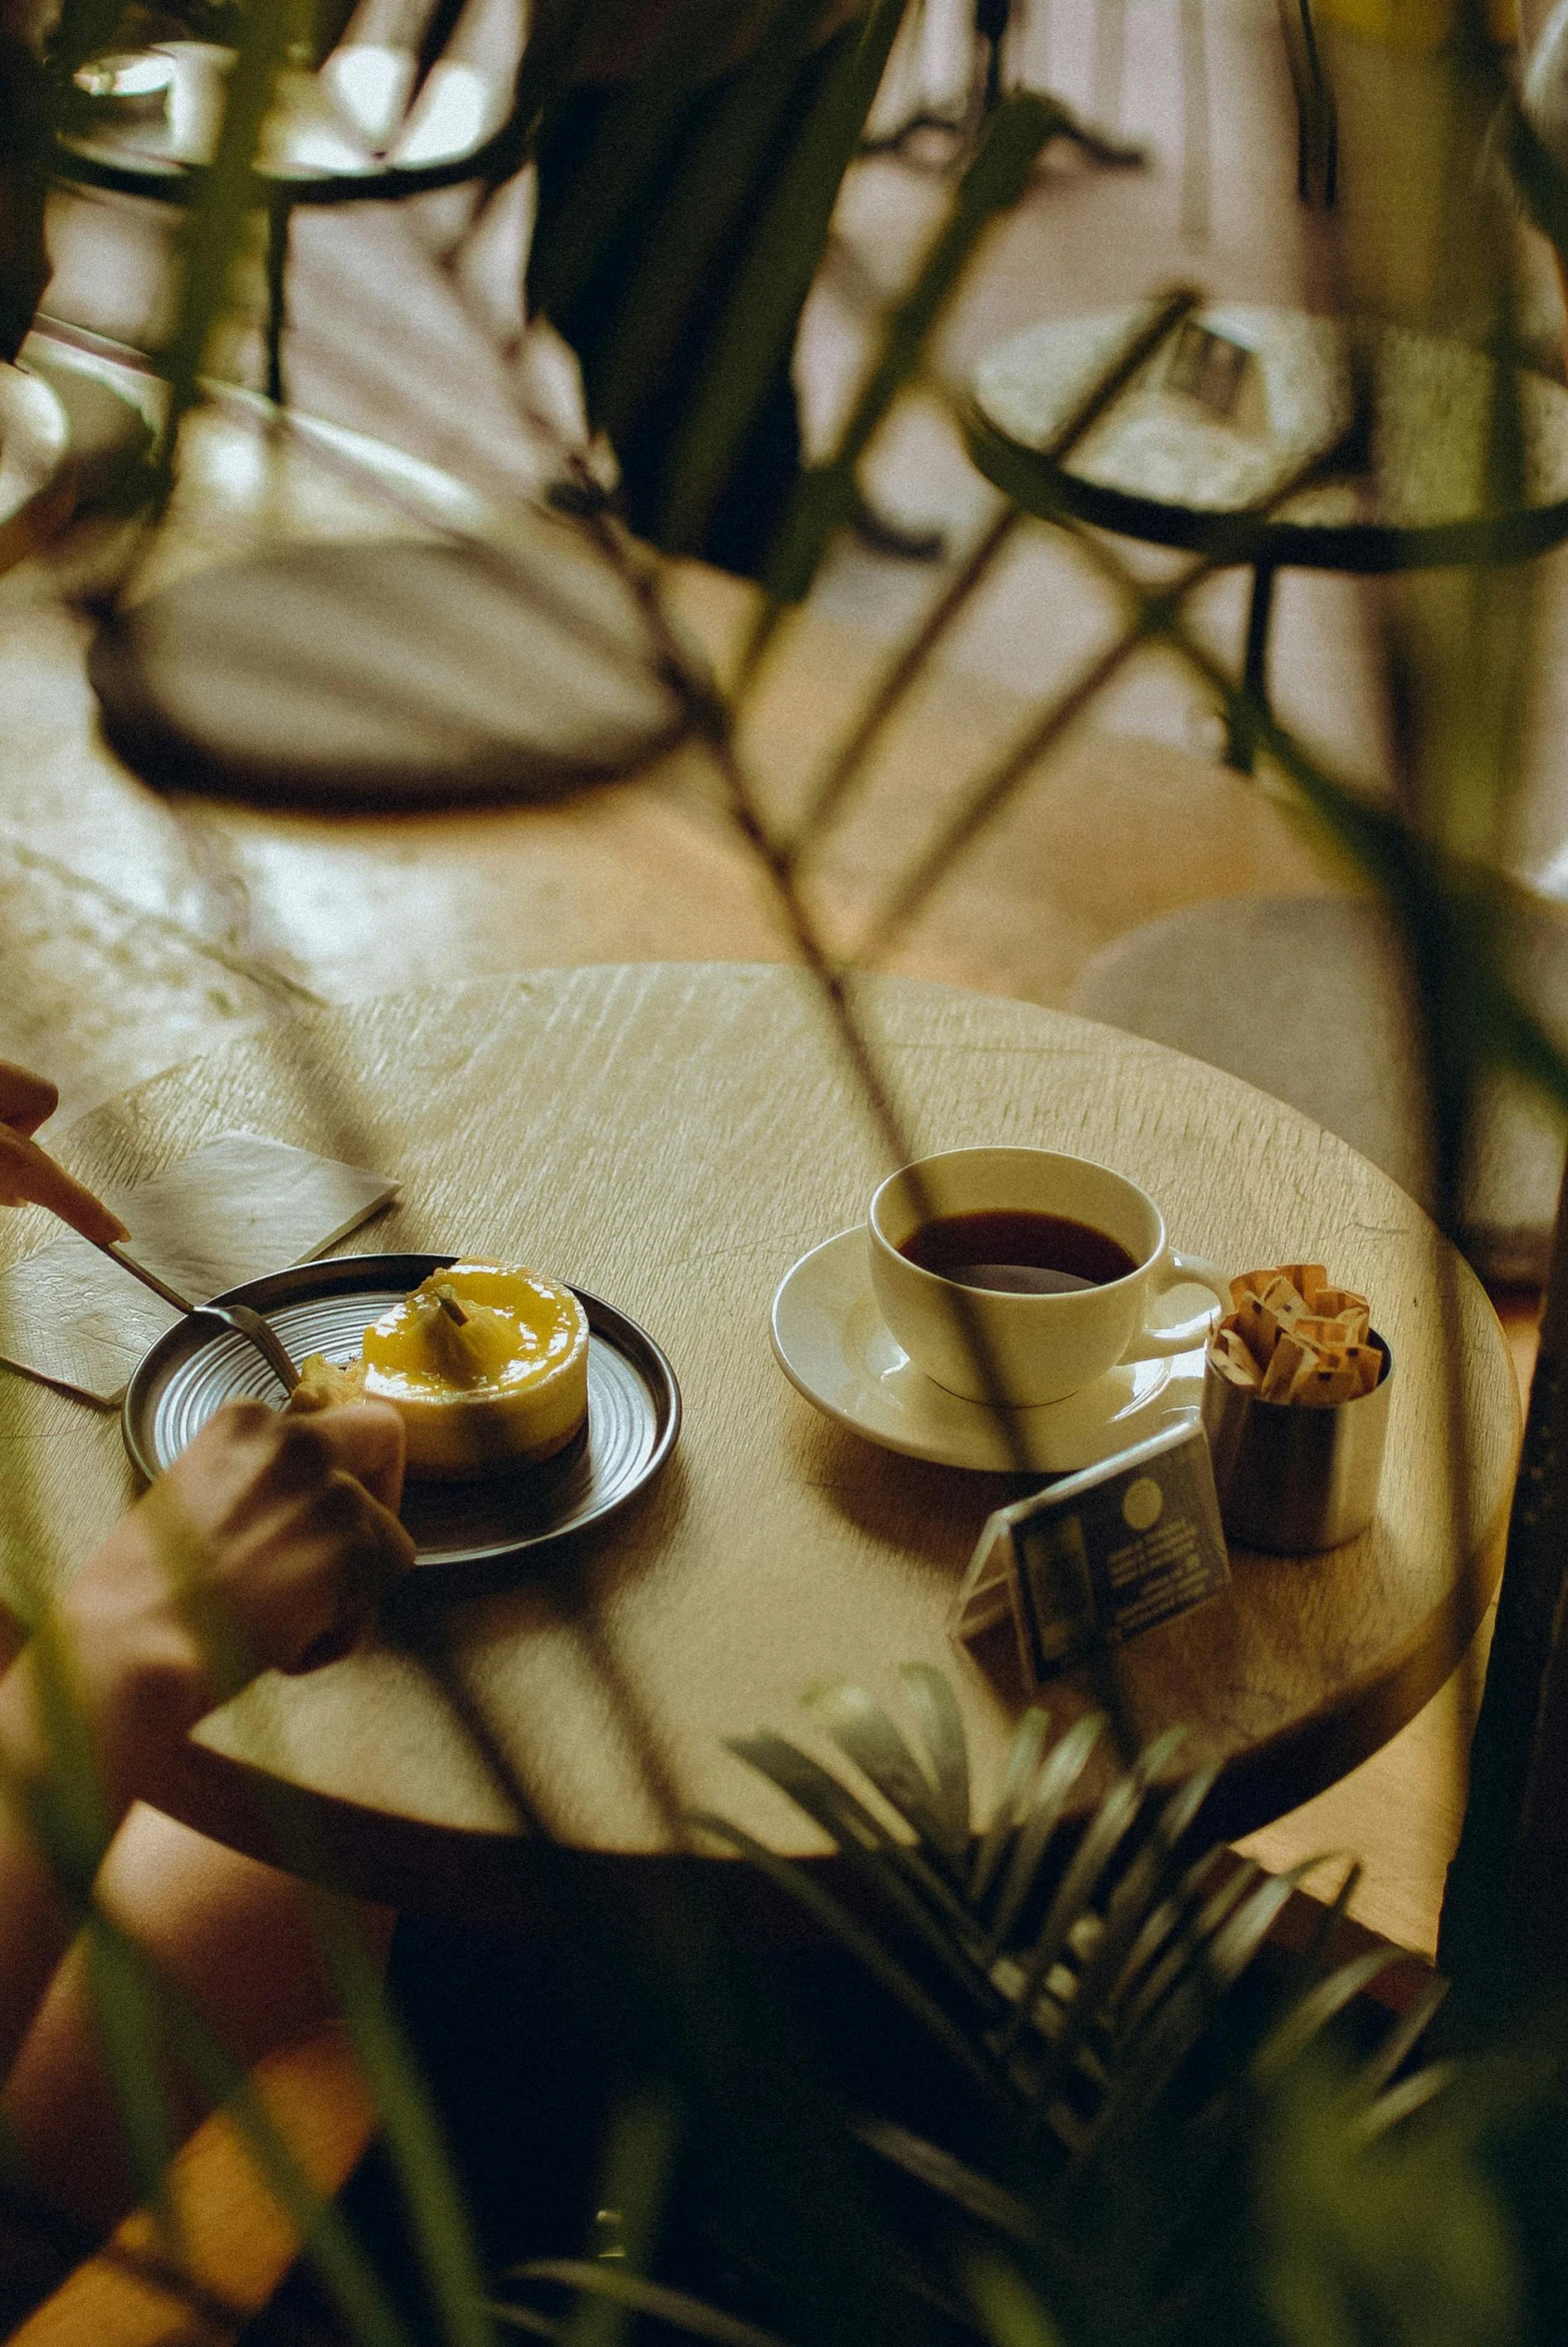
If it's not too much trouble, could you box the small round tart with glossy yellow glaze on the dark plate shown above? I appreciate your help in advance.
[291,1260,590,1476]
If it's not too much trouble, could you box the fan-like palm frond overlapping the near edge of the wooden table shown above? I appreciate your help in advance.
[723,1668,1432,2190]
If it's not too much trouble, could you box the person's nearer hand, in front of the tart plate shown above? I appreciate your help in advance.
[0,1401,413,1823]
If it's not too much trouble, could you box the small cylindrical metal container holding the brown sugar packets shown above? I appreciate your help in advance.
[1204,1328,1394,1556]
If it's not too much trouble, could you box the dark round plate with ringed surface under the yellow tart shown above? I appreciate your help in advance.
[120,1255,681,1586]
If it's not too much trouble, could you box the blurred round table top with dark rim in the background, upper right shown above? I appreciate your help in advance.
[969,303,1568,573]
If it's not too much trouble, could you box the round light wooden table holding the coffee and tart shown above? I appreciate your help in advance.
[0,965,1519,1913]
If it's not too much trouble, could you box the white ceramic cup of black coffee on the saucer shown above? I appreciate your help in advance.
[868,1151,1230,1408]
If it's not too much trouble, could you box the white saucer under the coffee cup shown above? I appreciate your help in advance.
[773,1222,1204,1474]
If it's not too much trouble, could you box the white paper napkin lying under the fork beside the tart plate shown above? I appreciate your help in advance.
[0,1134,397,1403]
